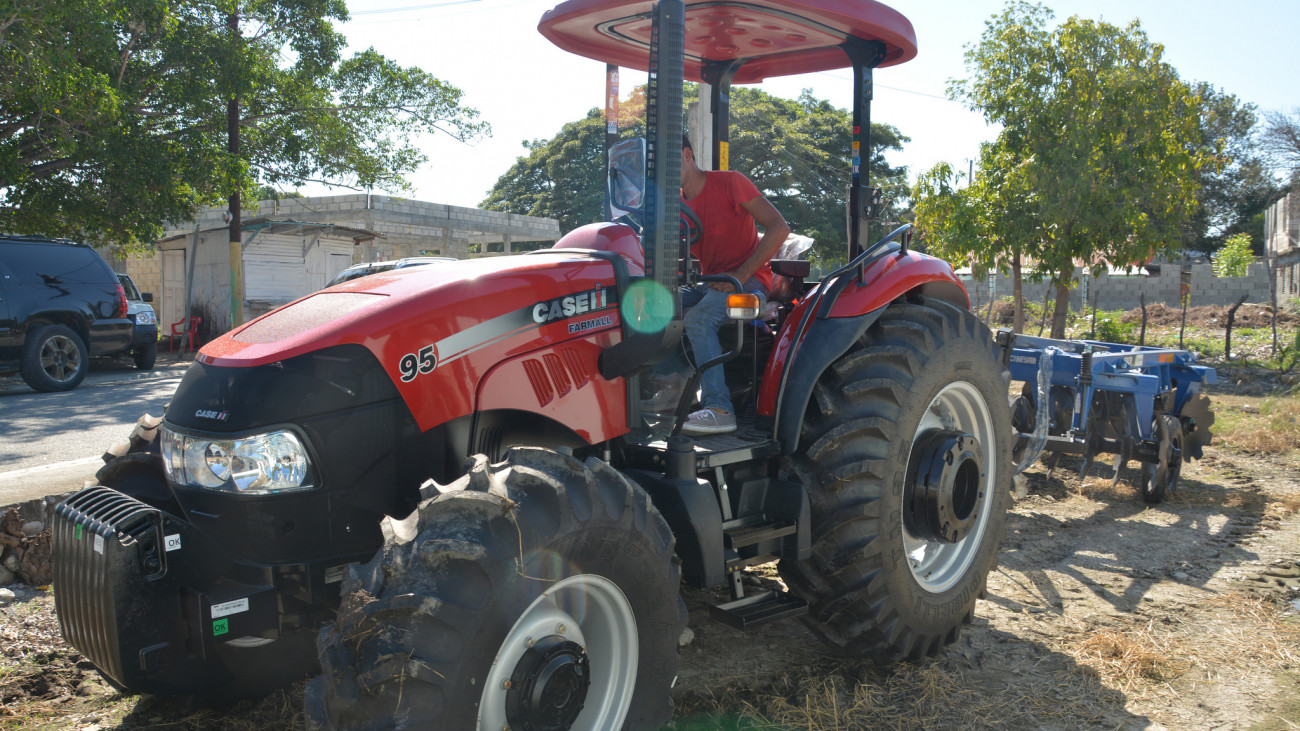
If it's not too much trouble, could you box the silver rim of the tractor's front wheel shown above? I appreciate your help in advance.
[478,574,638,731]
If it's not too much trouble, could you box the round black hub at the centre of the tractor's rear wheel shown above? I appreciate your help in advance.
[904,429,985,544]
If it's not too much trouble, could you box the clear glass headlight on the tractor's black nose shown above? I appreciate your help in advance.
[163,427,316,494]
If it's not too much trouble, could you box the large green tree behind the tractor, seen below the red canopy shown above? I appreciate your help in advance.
[480,85,907,263]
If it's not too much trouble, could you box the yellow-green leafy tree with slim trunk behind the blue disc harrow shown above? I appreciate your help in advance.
[950,1,1210,337]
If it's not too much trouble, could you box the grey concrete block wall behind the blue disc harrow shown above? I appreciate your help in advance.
[962,261,1269,311]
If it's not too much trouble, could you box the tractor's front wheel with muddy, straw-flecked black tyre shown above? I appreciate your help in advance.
[307,447,686,731]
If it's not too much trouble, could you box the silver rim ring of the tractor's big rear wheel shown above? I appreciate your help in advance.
[902,381,1005,593]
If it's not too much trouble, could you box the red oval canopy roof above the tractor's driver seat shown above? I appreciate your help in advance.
[538,0,917,83]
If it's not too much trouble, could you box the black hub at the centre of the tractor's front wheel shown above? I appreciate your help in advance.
[506,635,592,731]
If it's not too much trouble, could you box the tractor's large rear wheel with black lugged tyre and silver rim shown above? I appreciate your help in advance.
[780,298,1013,662]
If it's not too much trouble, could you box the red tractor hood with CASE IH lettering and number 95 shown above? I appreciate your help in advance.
[184,249,621,436]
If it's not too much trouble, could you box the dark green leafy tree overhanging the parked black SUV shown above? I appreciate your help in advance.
[0,0,486,243]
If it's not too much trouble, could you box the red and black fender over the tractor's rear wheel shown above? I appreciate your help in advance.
[758,251,970,454]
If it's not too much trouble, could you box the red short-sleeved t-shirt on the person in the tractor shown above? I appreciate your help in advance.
[681,170,772,291]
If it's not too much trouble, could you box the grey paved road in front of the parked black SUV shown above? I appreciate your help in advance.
[0,356,190,506]
